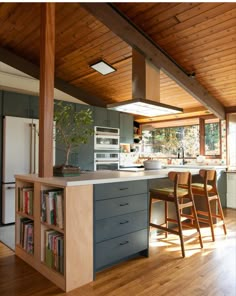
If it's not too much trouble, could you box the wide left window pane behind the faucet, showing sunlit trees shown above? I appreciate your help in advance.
[142,125,200,157]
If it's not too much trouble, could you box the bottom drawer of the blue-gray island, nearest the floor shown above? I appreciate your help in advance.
[95,229,148,270]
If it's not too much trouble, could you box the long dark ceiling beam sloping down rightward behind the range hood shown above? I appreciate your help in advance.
[80,3,225,119]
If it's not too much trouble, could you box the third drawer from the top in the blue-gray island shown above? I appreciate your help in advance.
[95,211,148,243]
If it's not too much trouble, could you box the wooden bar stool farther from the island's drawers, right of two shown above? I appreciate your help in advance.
[192,169,227,241]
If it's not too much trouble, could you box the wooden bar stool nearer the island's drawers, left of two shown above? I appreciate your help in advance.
[149,172,203,257]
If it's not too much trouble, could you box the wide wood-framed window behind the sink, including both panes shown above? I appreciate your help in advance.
[142,118,221,158]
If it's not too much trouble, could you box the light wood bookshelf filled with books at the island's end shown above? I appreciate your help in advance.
[16,175,94,292]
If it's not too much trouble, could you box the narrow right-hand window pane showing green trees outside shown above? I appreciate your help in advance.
[205,122,220,155]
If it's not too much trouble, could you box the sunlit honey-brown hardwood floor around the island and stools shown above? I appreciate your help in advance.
[0,209,236,296]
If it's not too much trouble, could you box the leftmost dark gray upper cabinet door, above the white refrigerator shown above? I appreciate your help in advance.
[3,91,30,118]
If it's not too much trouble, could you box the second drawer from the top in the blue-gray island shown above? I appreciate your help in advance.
[95,193,148,220]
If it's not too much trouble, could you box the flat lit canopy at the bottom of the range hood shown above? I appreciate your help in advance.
[107,99,183,117]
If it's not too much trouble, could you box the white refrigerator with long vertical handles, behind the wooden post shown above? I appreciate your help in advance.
[2,116,39,224]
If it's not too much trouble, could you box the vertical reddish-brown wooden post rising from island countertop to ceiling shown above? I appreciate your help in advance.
[39,2,55,177]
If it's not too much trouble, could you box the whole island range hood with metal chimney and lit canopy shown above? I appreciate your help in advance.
[107,49,183,117]
